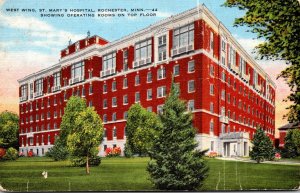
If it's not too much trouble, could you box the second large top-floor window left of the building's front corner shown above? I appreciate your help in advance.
[134,39,152,62]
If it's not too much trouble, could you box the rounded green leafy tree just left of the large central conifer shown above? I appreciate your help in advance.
[126,104,159,155]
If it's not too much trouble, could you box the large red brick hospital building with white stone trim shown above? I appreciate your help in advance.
[19,6,275,156]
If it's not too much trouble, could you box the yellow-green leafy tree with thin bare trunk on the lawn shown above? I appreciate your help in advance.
[67,107,104,174]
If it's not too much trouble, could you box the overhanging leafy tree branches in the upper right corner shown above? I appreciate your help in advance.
[224,0,300,122]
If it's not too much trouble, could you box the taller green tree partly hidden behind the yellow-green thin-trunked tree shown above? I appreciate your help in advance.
[58,96,87,146]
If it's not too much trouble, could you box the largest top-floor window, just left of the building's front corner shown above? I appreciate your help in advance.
[173,23,194,48]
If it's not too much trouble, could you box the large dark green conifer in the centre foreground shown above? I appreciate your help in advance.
[147,83,208,190]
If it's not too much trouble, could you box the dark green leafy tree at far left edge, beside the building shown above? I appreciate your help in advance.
[0,111,19,149]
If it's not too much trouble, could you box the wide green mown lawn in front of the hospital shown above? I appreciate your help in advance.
[0,157,300,191]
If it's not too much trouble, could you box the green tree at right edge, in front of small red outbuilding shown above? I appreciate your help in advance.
[282,129,300,158]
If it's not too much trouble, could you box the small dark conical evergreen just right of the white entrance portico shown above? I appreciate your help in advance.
[250,128,275,163]
